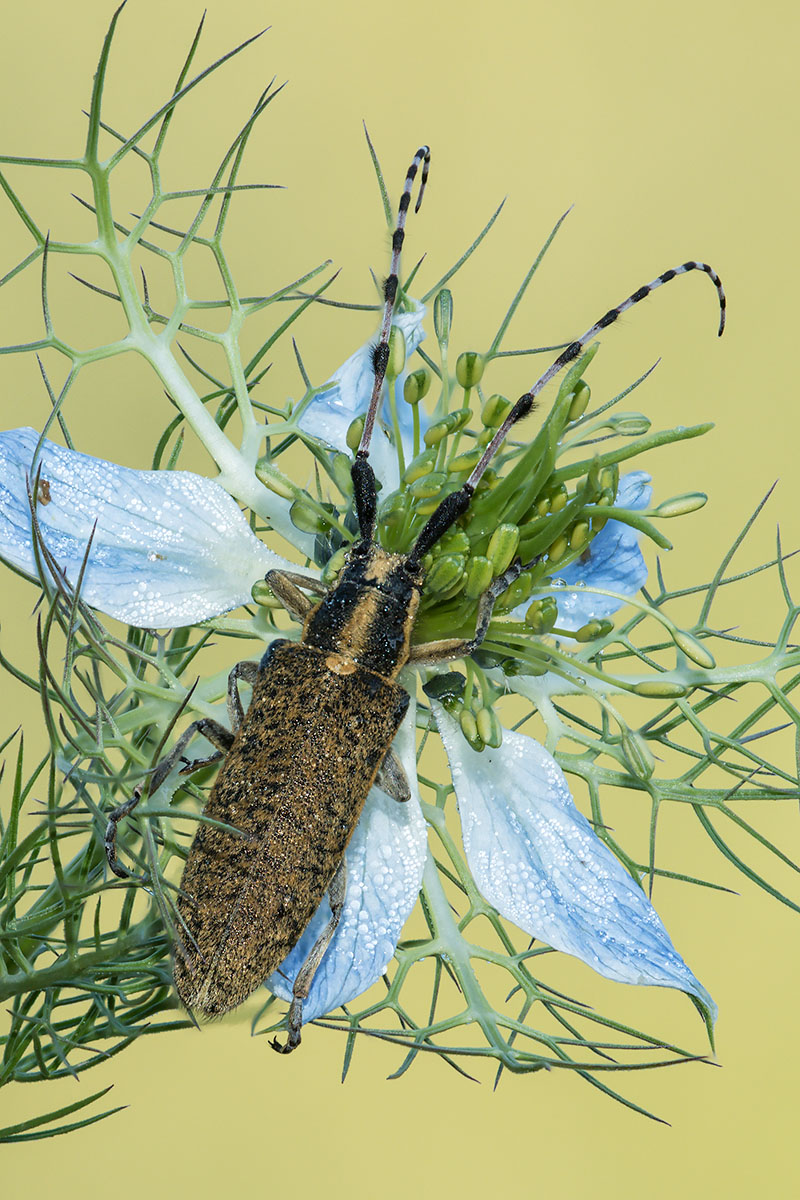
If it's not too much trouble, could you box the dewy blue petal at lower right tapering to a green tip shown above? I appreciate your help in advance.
[434,703,717,1020]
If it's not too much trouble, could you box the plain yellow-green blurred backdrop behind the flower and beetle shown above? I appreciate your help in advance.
[0,0,800,1200]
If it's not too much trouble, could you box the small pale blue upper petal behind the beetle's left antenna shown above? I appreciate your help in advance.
[297,301,426,491]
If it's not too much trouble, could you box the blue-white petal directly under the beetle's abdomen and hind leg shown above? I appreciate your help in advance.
[266,701,427,1022]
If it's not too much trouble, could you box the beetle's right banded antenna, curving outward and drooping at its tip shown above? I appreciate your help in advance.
[409,260,726,565]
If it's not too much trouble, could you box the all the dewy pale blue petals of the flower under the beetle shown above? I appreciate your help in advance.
[0,360,716,1036]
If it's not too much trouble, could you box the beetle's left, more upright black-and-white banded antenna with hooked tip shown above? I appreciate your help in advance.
[350,146,431,540]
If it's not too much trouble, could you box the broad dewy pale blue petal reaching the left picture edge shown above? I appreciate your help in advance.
[0,428,290,628]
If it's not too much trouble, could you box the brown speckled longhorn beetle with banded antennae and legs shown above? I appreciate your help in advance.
[106,146,726,1054]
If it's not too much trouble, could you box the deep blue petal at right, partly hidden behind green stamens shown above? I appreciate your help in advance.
[557,470,652,629]
